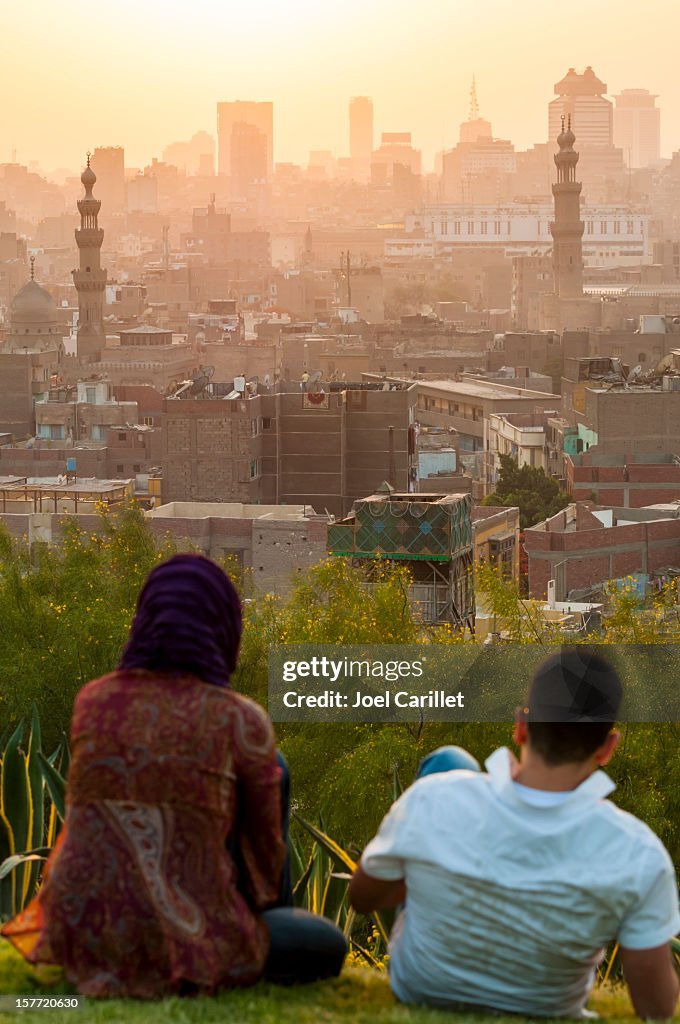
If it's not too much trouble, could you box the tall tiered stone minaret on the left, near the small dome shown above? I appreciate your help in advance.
[73,153,107,356]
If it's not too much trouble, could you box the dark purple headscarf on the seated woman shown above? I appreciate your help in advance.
[119,555,242,686]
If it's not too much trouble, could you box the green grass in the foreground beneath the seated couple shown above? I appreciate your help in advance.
[0,940,655,1024]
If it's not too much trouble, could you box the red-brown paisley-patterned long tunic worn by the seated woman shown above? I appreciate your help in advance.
[2,670,285,998]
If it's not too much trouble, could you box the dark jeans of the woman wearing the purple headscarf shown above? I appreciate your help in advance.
[262,752,347,985]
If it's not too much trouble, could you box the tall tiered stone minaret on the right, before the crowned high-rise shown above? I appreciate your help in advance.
[550,118,584,299]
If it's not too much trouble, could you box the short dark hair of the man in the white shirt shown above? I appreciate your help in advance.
[523,646,623,765]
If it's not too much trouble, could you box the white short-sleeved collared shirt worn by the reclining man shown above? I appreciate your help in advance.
[362,748,680,1017]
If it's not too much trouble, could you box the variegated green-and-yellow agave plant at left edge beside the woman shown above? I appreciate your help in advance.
[0,708,68,921]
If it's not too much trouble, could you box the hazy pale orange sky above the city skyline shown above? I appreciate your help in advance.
[5,0,680,169]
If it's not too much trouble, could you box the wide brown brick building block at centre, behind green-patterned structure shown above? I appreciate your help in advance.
[163,382,418,515]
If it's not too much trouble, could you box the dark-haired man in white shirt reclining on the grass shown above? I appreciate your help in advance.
[350,647,680,1019]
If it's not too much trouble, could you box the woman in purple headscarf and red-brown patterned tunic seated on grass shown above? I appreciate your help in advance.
[2,555,346,998]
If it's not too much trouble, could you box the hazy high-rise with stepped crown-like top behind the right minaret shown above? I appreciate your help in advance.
[548,68,613,152]
